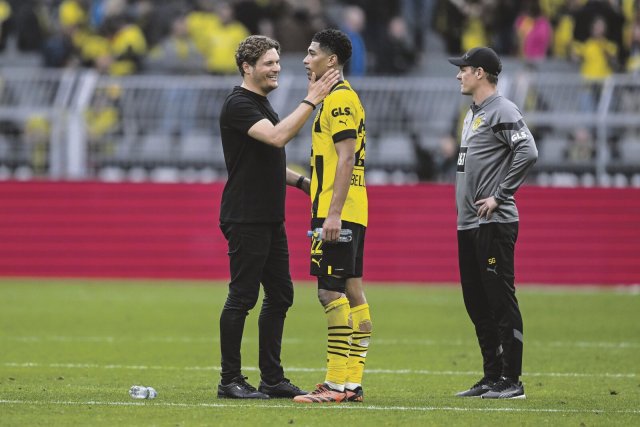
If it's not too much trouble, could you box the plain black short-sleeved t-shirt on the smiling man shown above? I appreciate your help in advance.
[220,86,287,223]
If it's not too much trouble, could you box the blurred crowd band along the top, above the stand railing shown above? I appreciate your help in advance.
[0,0,640,79]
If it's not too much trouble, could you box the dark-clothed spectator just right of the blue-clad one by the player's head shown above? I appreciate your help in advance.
[376,16,418,75]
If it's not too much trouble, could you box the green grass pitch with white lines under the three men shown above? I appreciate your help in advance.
[0,279,640,426]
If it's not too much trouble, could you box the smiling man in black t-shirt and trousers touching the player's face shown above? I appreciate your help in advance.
[218,36,339,399]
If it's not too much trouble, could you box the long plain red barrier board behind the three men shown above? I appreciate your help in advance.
[0,182,640,284]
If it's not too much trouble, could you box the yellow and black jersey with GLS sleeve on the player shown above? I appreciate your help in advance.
[311,80,369,227]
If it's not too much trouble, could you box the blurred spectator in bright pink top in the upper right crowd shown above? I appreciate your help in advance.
[515,0,553,63]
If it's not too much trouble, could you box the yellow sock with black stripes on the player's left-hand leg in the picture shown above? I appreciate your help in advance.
[324,297,353,387]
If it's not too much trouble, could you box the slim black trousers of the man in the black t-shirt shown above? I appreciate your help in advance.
[220,223,293,385]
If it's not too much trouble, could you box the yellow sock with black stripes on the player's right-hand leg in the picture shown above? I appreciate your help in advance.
[346,304,371,389]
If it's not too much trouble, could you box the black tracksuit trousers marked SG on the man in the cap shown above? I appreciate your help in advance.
[458,222,523,377]
